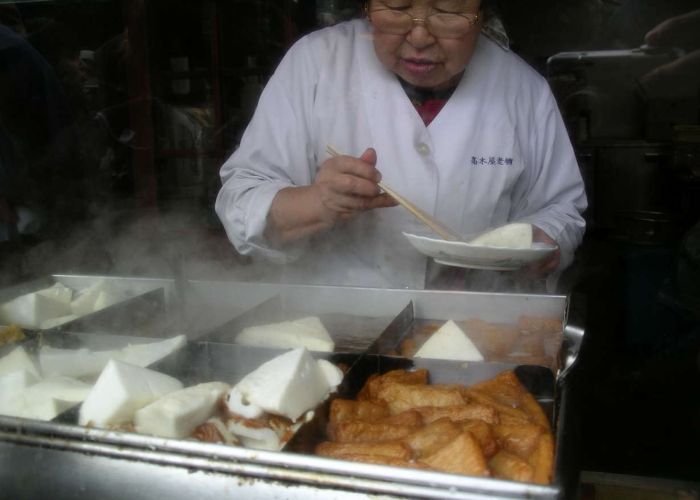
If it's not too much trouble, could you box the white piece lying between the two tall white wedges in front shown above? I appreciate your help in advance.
[134,382,230,438]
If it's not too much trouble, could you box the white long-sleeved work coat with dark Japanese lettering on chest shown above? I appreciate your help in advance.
[216,19,586,288]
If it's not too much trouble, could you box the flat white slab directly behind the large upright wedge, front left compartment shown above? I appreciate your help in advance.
[39,346,120,378]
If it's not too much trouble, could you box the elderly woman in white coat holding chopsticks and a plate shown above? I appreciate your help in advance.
[216,0,586,288]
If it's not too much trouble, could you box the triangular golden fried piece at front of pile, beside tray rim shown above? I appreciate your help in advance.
[421,432,489,476]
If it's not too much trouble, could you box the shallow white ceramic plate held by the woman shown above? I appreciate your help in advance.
[403,233,557,271]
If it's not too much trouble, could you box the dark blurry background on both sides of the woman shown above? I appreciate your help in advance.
[0,0,700,492]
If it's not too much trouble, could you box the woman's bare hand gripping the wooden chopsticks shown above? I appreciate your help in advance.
[313,148,396,223]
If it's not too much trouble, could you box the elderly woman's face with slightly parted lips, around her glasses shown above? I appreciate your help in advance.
[368,0,480,90]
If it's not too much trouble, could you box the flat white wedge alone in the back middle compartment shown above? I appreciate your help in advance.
[235,316,335,352]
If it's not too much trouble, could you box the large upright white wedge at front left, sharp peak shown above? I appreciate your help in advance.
[79,360,182,427]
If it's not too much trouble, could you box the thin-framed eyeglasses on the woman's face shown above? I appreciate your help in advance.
[367,8,479,38]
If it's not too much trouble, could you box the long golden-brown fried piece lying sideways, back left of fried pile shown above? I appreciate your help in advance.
[377,383,464,415]
